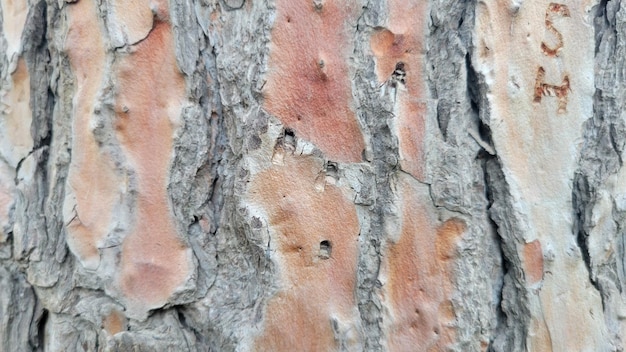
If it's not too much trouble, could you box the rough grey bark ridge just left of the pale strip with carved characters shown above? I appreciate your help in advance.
[424,0,508,350]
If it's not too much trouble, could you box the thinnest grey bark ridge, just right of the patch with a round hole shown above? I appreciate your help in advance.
[353,7,399,351]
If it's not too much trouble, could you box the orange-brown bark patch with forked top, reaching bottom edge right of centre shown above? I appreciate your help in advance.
[386,180,465,351]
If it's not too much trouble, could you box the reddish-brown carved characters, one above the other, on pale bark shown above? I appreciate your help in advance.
[534,3,570,114]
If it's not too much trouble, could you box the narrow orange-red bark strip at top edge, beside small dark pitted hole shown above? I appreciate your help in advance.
[370,0,428,180]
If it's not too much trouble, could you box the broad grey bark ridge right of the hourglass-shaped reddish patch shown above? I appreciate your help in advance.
[178,2,275,350]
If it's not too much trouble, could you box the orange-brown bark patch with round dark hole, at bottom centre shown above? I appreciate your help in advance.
[251,154,359,351]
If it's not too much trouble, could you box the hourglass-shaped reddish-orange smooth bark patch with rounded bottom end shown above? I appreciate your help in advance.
[115,22,191,308]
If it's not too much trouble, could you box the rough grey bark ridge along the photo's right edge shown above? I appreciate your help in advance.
[572,0,626,346]
